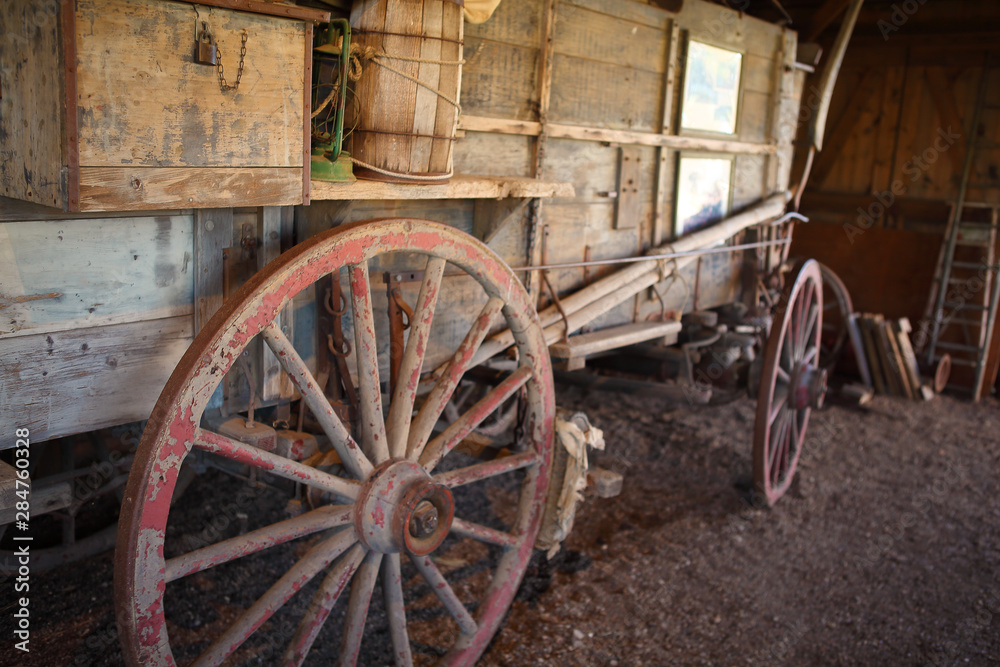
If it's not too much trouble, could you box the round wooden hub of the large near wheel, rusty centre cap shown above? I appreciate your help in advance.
[354,459,455,556]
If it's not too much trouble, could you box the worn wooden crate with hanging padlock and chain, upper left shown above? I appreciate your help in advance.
[0,0,329,211]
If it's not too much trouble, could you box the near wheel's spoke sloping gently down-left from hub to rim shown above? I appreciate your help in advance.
[166,505,354,582]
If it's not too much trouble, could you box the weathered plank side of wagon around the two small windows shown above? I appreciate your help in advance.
[455,0,802,327]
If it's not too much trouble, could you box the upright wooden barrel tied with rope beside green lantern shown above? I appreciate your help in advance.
[345,0,463,182]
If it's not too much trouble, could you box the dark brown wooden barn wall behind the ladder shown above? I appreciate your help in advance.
[793,14,1000,386]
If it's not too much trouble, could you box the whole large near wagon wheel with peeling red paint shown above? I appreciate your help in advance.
[115,219,554,665]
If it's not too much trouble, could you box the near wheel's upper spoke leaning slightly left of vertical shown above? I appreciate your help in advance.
[348,262,389,464]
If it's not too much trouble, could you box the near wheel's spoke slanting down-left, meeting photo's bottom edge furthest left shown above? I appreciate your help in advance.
[194,528,357,667]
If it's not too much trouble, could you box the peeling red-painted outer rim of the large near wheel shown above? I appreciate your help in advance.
[115,219,554,665]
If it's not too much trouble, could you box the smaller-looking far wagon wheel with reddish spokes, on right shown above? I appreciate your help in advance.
[753,260,826,506]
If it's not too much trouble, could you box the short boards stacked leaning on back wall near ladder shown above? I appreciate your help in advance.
[852,313,934,400]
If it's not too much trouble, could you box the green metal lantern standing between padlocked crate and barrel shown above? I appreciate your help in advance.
[310,19,356,183]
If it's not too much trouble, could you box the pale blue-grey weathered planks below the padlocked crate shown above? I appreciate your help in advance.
[0,202,194,449]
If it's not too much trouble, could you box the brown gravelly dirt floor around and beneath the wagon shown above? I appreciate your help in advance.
[0,389,1000,667]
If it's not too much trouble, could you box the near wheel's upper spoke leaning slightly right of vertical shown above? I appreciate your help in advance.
[385,257,447,458]
